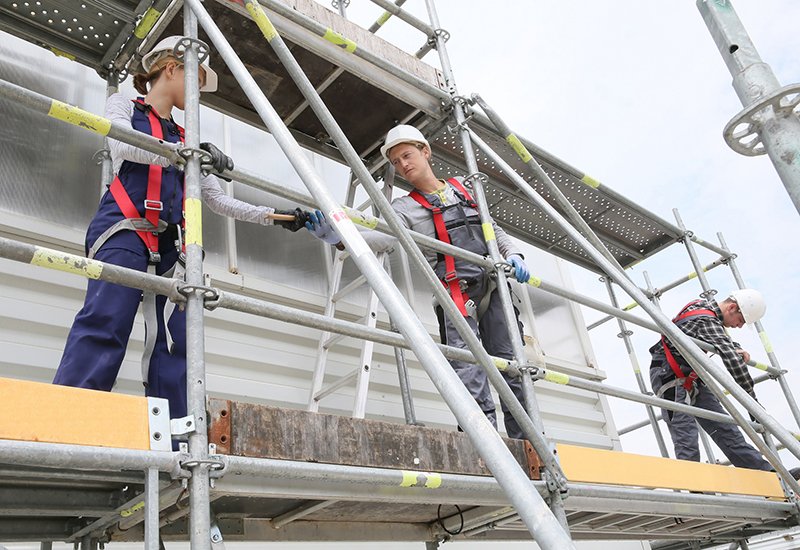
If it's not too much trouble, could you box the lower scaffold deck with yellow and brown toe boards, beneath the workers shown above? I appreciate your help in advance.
[0,379,794,548]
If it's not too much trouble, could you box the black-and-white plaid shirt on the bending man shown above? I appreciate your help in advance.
[650,300,754,395]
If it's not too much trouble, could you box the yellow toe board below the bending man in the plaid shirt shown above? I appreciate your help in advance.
[556,444,784,499]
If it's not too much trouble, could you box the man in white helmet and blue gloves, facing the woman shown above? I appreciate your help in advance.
[308,124,530,438]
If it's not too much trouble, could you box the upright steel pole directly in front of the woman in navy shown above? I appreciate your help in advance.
[183,7,211,550]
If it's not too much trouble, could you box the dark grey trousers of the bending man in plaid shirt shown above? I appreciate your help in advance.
[650,362,772,471]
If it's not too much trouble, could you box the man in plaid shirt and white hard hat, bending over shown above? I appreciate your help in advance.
[650,288,772,471]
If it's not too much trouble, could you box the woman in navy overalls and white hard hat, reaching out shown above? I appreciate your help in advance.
[54,36,304,432]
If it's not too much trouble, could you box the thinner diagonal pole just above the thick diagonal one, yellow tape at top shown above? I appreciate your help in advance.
[228,0,566,489]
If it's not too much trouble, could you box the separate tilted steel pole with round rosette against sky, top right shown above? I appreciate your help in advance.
[697,0,800,216]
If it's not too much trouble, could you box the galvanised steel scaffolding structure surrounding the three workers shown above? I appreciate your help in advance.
[0,0,800,550]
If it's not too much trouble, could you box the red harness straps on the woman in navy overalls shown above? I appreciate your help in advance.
[109,99,184,263]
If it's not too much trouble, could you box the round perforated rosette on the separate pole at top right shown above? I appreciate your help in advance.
[722,84,800,157]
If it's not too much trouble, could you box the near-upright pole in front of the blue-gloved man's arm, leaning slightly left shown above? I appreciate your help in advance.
[418,0,569,532]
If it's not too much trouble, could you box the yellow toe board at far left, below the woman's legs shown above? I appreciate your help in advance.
[0,378,150,450]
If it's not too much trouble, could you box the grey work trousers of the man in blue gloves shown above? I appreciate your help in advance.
[436,291,525,439]
